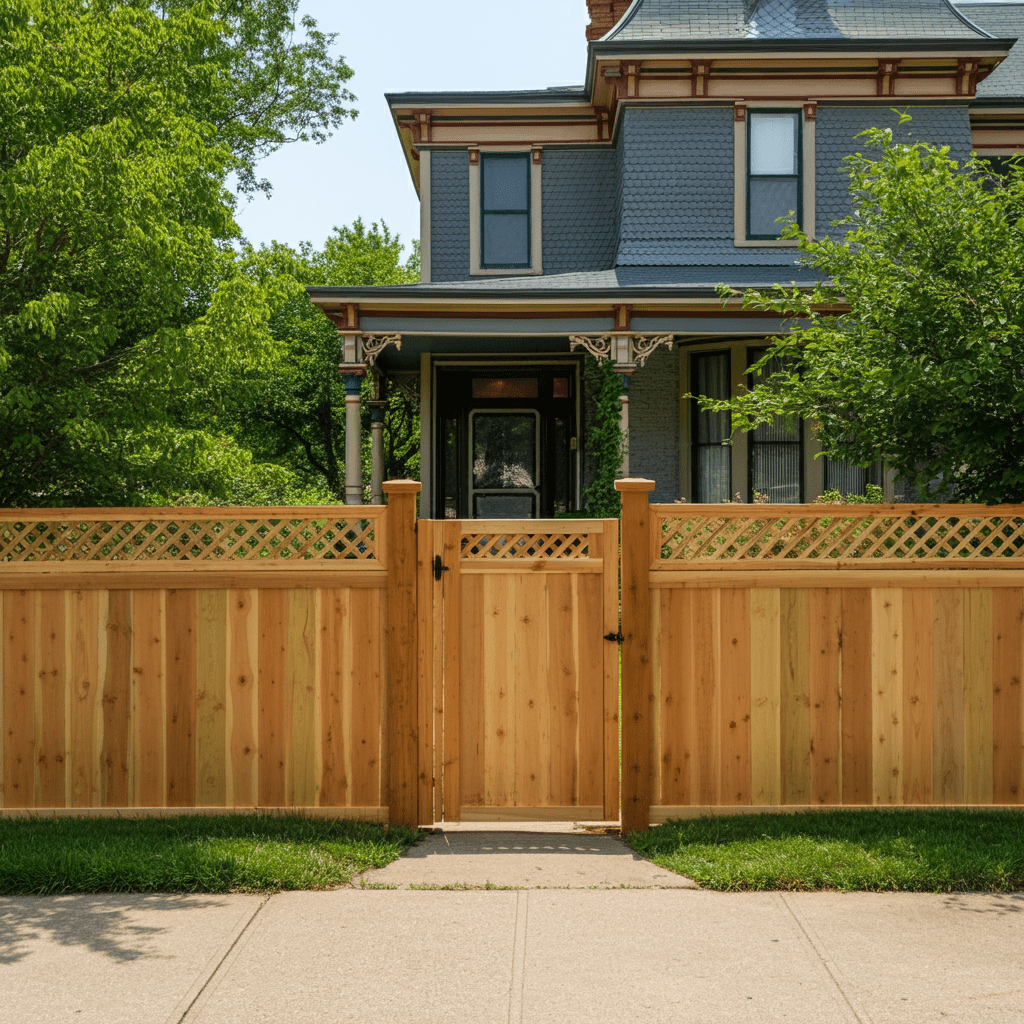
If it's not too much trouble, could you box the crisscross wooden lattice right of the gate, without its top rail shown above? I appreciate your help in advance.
[662,512,1024,563]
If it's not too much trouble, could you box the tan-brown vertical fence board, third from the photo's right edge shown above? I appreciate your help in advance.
[932,588,964,804]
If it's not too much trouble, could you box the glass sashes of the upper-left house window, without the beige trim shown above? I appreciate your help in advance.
[480,153,530,269]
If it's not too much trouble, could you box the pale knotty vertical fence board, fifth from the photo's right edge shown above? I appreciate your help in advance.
[871,588,903,804]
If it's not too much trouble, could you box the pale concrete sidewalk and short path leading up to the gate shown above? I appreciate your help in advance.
[0,833,1024,1024]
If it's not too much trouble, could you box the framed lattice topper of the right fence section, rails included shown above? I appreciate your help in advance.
[651,505,1024,569]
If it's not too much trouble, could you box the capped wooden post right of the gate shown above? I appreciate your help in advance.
[615,478,654,835]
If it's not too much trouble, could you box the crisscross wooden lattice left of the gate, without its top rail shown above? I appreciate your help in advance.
[0,516,376,562]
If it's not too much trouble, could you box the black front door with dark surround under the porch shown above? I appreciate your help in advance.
[434,365,579,519]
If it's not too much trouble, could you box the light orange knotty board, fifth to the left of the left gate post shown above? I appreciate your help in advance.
[225,590,260,807]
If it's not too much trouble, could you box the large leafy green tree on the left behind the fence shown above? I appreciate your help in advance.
[0,0,351,505]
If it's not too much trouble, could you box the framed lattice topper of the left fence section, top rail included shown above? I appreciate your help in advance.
[0,506,383,563]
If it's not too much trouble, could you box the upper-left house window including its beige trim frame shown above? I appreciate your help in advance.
[469,146,544,278]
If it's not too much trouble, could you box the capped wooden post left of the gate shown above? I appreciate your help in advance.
[384,480,420,827]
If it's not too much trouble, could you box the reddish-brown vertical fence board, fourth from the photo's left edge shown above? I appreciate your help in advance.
[99,590,132,807]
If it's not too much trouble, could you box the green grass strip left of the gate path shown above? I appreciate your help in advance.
[0,814,418,896]
